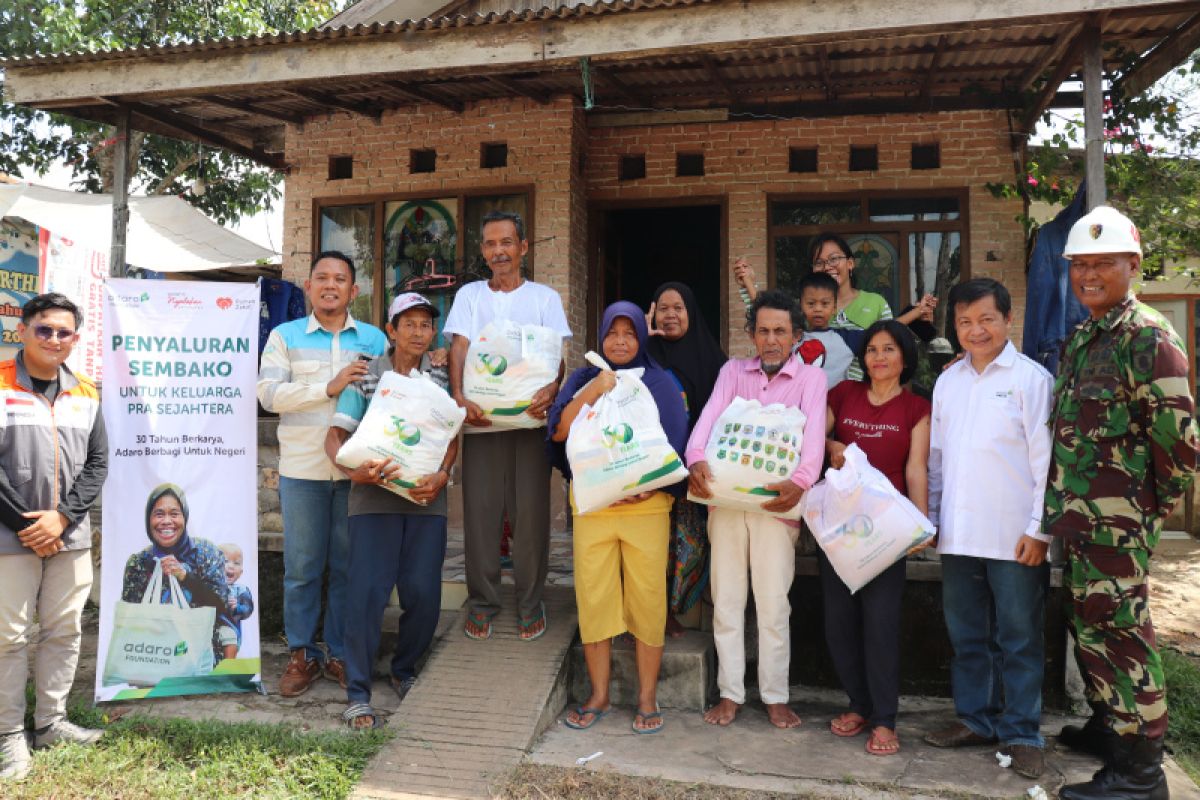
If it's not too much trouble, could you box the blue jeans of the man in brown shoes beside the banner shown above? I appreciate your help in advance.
[280,476,350,662]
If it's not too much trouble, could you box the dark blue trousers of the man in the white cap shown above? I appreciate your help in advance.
[346,513,446,703]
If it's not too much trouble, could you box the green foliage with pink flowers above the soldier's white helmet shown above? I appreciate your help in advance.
[988,52,1200,275]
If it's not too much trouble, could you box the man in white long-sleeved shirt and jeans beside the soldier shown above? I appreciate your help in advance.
[925,278,1052,778]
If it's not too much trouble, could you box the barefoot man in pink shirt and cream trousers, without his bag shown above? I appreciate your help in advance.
[686,290,827,728]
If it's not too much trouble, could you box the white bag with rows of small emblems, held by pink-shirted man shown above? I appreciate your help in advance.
[688,397,805,519]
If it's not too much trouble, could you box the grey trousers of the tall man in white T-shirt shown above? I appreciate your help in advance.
[462,428,550,619]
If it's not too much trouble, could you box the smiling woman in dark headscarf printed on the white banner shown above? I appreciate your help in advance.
[121,483,231,662]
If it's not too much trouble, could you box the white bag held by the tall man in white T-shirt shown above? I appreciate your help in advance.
[462,319,563,433]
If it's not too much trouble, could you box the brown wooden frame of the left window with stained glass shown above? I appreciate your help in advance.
[310,184,538,327]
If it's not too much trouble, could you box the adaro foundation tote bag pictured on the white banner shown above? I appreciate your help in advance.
[103,560,217,686]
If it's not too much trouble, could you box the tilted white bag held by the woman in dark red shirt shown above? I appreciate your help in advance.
[800,445,936,593]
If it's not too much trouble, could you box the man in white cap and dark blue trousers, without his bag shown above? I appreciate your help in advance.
[325,291,458,729]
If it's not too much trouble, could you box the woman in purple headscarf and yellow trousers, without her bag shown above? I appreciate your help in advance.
[547,301,688,734]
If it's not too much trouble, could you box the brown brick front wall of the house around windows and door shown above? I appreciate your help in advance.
[283,103,1025,361]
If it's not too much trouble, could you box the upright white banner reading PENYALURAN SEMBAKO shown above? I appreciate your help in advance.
[96,279,260,700]
